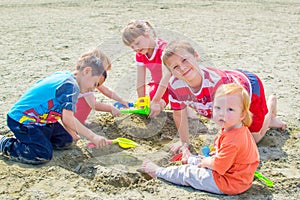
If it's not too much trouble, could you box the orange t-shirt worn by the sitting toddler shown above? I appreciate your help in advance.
[212,126,259,195]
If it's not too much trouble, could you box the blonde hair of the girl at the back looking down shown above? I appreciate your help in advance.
[121,20,156,46]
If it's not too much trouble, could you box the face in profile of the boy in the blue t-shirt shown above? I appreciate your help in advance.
[77,67,102,93]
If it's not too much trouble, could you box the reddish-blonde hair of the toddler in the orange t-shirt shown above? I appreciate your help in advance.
[214,83,252,127]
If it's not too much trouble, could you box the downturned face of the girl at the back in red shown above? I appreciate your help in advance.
[130,34,154,55]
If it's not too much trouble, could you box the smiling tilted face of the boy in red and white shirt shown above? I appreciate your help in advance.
[166,50,201,85]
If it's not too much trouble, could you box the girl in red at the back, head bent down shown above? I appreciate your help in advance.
[122,20,171,116]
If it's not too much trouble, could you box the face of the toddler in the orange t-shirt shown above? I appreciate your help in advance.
[213,94,244,130]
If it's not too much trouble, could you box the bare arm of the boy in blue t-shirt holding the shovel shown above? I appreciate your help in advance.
[62,109,108,148]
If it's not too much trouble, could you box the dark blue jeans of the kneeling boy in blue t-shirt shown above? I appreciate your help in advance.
[2,115,73,164]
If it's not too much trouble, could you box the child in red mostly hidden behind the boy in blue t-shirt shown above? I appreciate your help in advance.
[74,48,128,124]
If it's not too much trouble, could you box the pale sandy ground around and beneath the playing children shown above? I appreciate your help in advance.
[0,0,300,199]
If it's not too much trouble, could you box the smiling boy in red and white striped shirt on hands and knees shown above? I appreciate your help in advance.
[162,41,286,153]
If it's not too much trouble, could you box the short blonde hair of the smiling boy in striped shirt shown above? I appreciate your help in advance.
[162,40,195,70]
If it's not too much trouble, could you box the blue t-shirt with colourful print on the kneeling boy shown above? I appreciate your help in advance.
[8,71,80,126]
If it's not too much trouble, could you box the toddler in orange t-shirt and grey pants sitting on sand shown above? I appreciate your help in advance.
[141,83,259,195]
